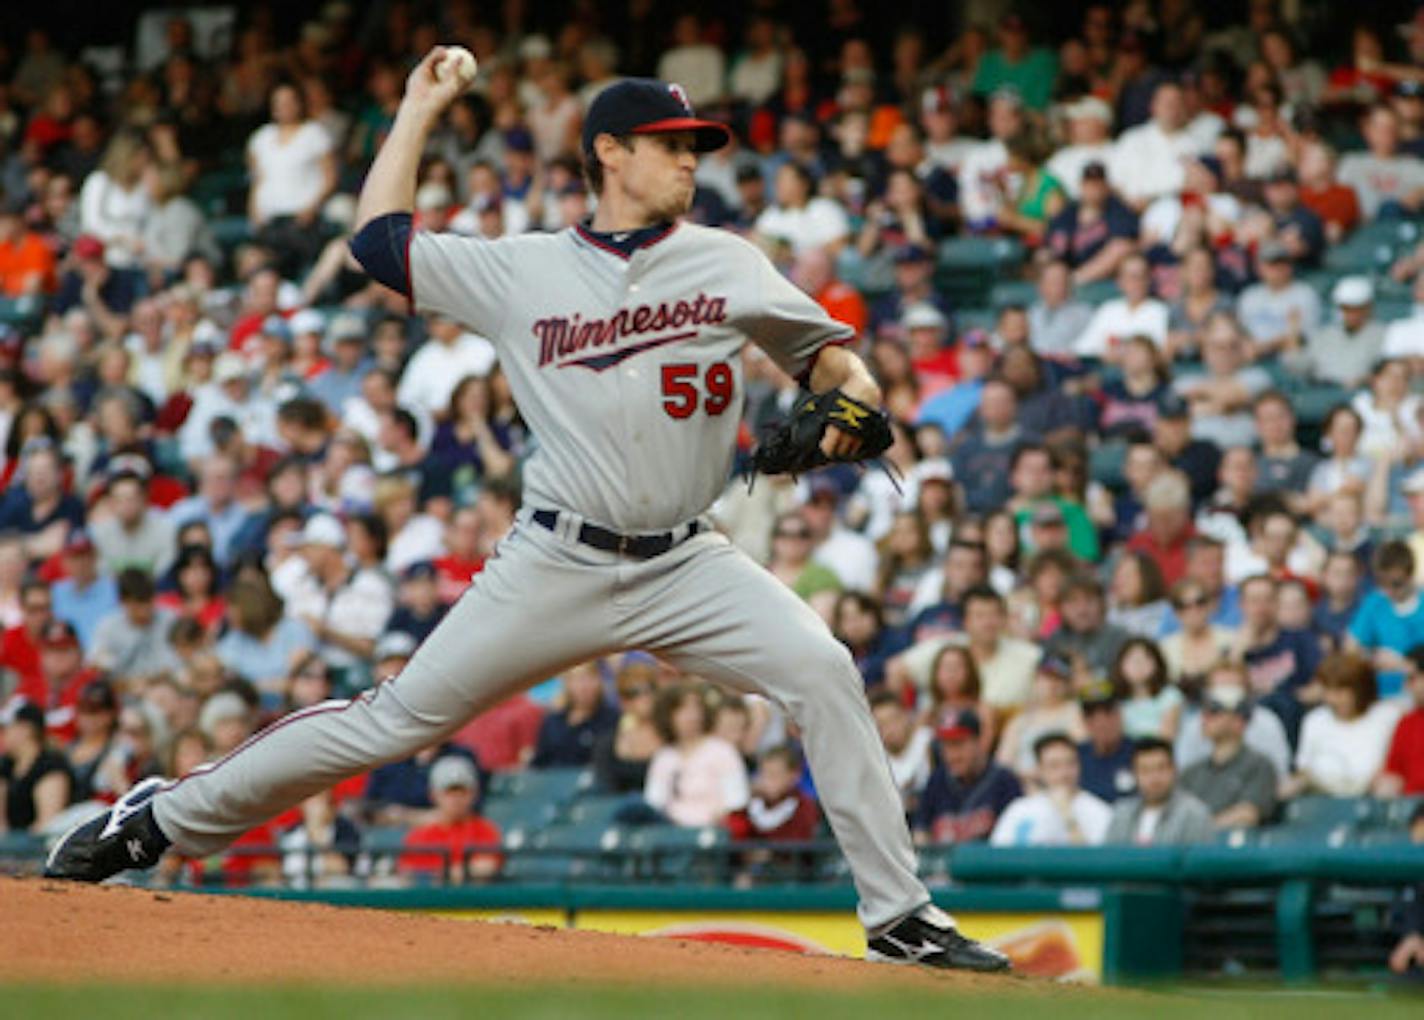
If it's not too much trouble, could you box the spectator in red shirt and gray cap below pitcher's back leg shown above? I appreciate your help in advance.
[399,755,504,883]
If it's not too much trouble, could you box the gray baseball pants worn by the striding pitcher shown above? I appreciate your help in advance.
[154,510,930,930]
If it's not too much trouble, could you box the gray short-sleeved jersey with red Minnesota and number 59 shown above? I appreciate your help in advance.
[410,224,852,531]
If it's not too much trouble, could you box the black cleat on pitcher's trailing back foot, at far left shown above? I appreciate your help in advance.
[44,779,168,882]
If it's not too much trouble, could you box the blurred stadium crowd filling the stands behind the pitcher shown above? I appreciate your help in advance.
[0,0,1424,923]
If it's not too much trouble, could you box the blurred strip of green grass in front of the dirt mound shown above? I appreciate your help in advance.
[0,984,1424,1020]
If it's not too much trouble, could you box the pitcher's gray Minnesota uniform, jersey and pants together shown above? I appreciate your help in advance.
[154,225,930,932]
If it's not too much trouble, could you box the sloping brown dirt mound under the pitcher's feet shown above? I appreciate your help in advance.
[0,879,1059,993]
